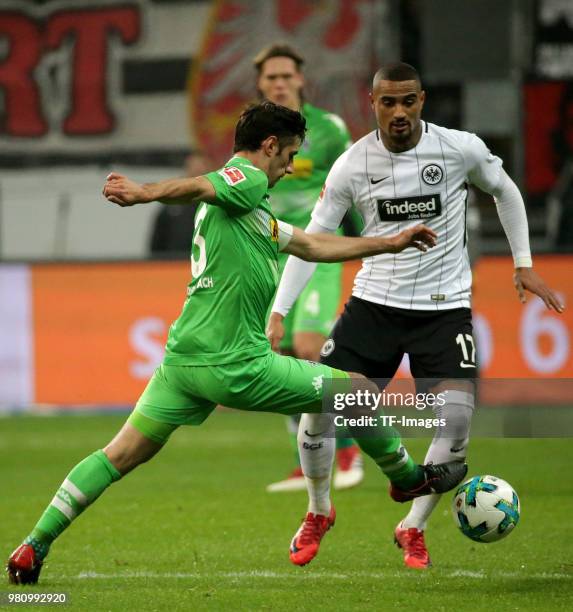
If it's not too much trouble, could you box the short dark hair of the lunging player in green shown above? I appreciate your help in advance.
[233,100,306,153]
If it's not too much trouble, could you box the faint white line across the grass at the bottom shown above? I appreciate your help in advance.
[72,570,573,580]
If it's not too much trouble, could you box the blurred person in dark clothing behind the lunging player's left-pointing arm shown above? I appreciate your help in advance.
[149,151,215,258]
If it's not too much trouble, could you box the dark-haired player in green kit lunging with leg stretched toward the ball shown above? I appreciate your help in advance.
[7,102,465,584]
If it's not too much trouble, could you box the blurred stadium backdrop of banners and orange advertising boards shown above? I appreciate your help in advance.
[0,0,573,412]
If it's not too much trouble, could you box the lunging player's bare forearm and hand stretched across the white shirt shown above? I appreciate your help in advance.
[284,225,437,262]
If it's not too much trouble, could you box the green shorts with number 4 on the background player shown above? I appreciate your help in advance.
[280,263,342,350]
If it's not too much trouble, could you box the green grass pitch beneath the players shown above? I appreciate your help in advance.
[0,412,573,611]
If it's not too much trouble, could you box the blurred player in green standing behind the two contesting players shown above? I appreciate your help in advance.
[254,44,364,492]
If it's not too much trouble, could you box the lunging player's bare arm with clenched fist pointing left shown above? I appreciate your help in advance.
[103,172,215,206]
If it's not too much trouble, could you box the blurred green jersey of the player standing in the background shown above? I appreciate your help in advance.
[271,103,352,229]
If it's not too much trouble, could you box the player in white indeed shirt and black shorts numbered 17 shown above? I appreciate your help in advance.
[268,62,563,568]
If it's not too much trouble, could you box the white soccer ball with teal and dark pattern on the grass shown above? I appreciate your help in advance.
[452,476,520,542]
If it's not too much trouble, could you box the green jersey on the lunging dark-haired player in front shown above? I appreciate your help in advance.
[164,157,279,365]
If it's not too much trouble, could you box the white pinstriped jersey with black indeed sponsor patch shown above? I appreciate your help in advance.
[312,121,502,310]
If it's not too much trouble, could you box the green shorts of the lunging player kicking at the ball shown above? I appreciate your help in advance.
[129,352,349,443]
